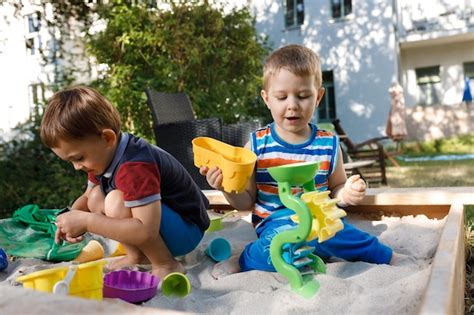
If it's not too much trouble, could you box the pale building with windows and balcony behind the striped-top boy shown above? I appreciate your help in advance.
[244,0,474,140]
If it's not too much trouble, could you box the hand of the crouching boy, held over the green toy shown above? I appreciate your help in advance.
[54,210,90,243]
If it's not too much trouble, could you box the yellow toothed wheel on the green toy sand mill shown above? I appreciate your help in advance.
[291,191,347,243]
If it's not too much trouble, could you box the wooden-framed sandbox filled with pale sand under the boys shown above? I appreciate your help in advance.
[0,187,474,314]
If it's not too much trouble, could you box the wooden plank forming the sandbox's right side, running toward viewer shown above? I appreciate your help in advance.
[419,204,465,314]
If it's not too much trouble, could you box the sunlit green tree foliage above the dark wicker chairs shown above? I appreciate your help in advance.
[88,1,268,137]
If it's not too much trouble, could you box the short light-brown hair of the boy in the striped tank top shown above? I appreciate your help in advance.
[263,45,322,90]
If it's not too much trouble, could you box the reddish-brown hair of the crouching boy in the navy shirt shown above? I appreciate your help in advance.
[40,86,121,148]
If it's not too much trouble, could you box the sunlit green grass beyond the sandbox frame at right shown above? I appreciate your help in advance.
[387,135,474,314]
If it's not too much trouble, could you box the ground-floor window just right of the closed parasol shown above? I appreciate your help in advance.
[415,66,441,105]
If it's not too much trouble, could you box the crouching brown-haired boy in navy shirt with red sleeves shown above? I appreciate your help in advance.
[41,86,209,279]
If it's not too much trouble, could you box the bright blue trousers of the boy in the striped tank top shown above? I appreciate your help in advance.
[239,210,392,271]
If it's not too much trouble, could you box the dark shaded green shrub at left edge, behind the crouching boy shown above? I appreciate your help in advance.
[0,119,87,218]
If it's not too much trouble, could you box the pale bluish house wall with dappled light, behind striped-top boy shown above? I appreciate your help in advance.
[248,0,397,141]
